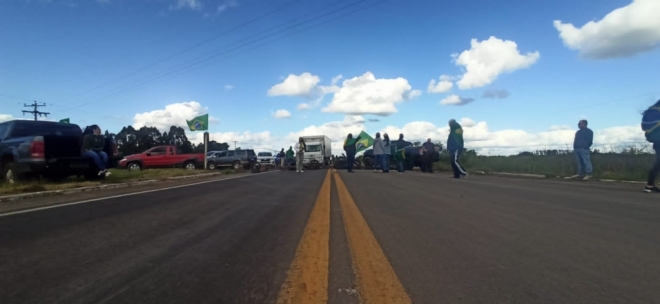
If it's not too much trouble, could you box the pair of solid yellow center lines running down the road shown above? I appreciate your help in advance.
[277,170,412,304]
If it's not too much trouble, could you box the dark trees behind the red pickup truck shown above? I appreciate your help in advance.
[105,126,229,155]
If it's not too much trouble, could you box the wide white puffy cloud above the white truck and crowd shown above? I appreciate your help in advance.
[323,72,421,116]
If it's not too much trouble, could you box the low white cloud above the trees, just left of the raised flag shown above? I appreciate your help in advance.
[133,101,218,131]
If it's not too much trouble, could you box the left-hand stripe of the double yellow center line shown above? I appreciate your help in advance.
[277,170,332,304]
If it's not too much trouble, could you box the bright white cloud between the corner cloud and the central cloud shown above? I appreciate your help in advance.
[452,36,540,90]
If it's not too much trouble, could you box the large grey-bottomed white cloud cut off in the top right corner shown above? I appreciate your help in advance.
[553,0,660,59]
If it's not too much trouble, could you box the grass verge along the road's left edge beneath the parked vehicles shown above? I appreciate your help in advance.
[0,169,243,196]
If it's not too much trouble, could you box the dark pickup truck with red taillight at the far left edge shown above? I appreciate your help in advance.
[0,120,120,183]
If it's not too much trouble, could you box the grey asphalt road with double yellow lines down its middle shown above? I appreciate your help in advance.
[0,171,660,303]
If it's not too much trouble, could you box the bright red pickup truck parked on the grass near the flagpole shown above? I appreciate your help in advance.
[119,146,204,171]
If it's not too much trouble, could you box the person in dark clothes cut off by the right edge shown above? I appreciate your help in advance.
[642,100,660,193]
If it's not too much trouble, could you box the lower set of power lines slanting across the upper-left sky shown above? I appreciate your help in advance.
[59,0,387,110]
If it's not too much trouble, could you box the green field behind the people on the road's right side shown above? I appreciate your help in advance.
[434,154,655,181]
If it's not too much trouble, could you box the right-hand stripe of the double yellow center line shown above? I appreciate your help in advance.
[334,174,412,304]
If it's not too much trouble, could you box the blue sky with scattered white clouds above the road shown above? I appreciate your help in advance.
[0,0,660,155]
